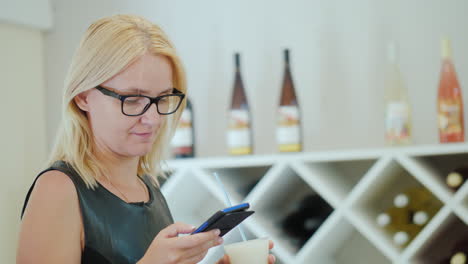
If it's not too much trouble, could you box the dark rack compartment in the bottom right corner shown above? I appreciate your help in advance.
[407,213,468,264]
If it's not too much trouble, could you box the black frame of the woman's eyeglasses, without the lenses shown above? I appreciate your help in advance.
[96,85,185,116]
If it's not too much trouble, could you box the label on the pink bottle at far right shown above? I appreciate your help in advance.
[439,99,463,135]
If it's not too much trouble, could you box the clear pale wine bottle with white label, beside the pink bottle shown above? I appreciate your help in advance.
[385,43,411,145]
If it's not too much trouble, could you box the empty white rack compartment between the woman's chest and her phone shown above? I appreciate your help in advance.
[162,169,224,229]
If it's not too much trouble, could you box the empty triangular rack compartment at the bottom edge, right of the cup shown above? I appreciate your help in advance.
[295,212,392,264]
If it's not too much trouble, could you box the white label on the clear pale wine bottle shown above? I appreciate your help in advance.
[385,101,410,142]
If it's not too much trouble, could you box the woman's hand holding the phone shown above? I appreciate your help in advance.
[137,223,223,264]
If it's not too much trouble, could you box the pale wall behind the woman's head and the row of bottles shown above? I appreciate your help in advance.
[46,0,468,156]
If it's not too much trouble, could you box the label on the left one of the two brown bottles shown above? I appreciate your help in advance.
[227,109,252,155]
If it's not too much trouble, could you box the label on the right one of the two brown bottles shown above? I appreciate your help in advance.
[276,106,301,152]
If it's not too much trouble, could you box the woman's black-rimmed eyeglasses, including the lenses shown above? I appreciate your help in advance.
[96,85,185,116]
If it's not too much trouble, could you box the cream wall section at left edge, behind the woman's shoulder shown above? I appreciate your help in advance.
[0,23,47,263]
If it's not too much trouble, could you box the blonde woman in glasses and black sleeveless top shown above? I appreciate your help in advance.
[17,15,274,264]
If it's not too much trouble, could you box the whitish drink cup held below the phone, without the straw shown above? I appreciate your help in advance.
[224,238,270,264]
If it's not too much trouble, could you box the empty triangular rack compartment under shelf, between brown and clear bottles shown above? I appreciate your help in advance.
[294,159,377,208]
